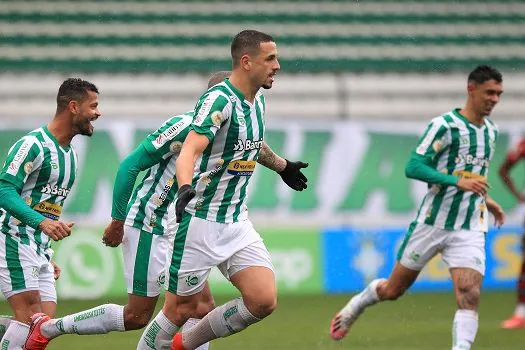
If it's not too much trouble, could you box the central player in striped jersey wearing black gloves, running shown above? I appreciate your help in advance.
[139,30,306,350]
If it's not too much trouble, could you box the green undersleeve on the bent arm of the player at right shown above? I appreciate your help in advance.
[405,152,458,186]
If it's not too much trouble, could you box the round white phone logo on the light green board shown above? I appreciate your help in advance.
[55,230,116,299]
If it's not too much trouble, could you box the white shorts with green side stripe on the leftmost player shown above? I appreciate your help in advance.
[0,233,57,303]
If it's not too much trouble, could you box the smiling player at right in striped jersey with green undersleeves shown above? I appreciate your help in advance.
[330,66,505,350]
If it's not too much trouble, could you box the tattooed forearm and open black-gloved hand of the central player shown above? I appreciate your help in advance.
[257,142,308,191]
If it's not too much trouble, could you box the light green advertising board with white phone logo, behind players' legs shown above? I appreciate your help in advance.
[53,227,322,299]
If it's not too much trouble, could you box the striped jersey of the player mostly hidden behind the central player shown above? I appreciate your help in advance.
[125,111,193,235]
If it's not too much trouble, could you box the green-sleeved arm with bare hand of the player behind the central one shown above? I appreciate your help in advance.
[102,145,160,247]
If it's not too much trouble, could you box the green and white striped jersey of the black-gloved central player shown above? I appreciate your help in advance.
[186,79,265,223]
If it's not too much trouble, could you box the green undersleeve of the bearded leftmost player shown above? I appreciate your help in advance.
[0,180,45,229]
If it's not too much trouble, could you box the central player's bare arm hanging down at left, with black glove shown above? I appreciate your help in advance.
[175,130,210,222]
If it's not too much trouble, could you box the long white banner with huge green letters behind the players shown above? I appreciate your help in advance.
[0,121,525,227]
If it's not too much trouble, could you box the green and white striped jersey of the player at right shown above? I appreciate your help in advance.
[415,109,498,232]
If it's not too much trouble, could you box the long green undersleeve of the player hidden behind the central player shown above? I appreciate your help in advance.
[111,144,161,221]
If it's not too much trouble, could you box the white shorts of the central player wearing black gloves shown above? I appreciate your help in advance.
[166,213,274,296]
